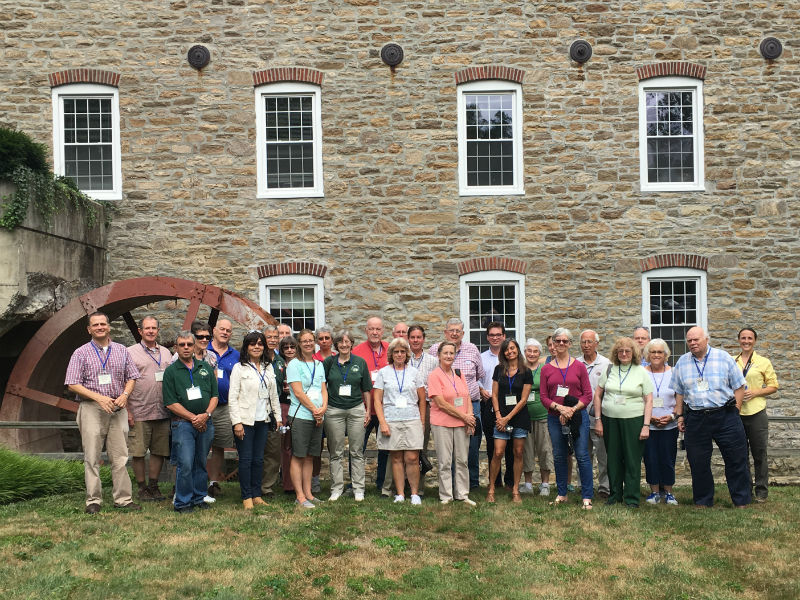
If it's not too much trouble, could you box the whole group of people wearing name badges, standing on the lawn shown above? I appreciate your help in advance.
[65,312,778,514]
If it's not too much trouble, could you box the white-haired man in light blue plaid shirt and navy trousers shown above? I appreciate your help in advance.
[672,327,751,508]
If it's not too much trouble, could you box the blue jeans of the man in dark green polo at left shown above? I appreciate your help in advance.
[172,419,214,508]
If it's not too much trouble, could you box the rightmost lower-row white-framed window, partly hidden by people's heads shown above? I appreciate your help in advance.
[642,268,708,365]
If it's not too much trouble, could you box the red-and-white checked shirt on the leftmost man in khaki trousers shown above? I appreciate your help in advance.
[64,342,139,402]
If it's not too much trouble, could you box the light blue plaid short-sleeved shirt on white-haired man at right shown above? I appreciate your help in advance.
[672,346,745,410]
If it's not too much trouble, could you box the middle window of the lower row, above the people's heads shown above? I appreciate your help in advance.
[459,271,525,352]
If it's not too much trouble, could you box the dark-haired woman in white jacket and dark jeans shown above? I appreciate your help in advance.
[228,331,281,510]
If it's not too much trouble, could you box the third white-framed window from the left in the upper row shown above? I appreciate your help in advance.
[458,80,525,196]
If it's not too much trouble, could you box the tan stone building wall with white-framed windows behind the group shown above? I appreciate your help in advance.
[0,0,800,446]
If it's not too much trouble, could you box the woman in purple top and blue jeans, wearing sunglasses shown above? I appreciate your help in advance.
[539,327,594,510]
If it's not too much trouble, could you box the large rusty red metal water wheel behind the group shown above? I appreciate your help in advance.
[0,277,276,452]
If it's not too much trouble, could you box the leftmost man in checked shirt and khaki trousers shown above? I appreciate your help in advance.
[64,312,142,515]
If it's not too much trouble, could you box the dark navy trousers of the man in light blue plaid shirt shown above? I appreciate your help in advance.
[684,408,752,506]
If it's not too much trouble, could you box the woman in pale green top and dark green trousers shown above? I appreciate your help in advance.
[594,337,653,508]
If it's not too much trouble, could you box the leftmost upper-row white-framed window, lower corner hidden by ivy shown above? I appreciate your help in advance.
[52,83,122,200]
